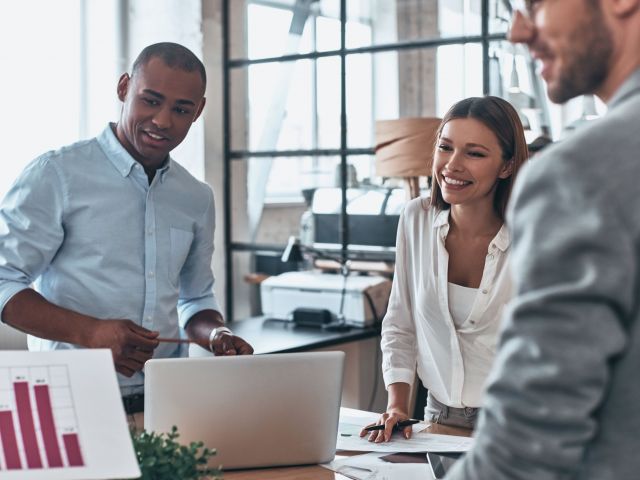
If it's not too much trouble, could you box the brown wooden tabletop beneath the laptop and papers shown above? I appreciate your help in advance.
[224,424,471,480]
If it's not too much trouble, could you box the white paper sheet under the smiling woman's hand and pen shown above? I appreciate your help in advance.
[336,408,473,453]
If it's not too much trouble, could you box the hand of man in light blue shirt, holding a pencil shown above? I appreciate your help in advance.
[87,320,159,377]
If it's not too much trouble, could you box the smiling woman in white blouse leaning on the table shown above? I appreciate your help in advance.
[368,96,527,442]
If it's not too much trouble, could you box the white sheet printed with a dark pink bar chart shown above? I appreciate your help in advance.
[0,350,140,480]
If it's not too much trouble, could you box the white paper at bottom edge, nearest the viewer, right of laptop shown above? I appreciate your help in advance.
[322,453,433,480]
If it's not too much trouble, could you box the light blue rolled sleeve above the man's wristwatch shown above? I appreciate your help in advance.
[178,189,221,328]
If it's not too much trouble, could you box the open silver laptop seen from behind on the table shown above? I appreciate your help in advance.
[144,352,344,469]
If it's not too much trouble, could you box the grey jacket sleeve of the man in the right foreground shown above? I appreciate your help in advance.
[447,152,637,480]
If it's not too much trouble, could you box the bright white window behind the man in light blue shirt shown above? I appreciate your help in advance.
[0,0,118,197]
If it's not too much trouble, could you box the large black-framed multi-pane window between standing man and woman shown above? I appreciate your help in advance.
[224,0,524,319]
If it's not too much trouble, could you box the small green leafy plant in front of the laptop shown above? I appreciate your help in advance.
[131,426,222,480]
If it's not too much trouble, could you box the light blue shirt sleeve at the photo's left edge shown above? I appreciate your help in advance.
[0,155,66,311]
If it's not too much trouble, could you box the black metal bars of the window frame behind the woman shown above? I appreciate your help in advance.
[222,0,506,322]
